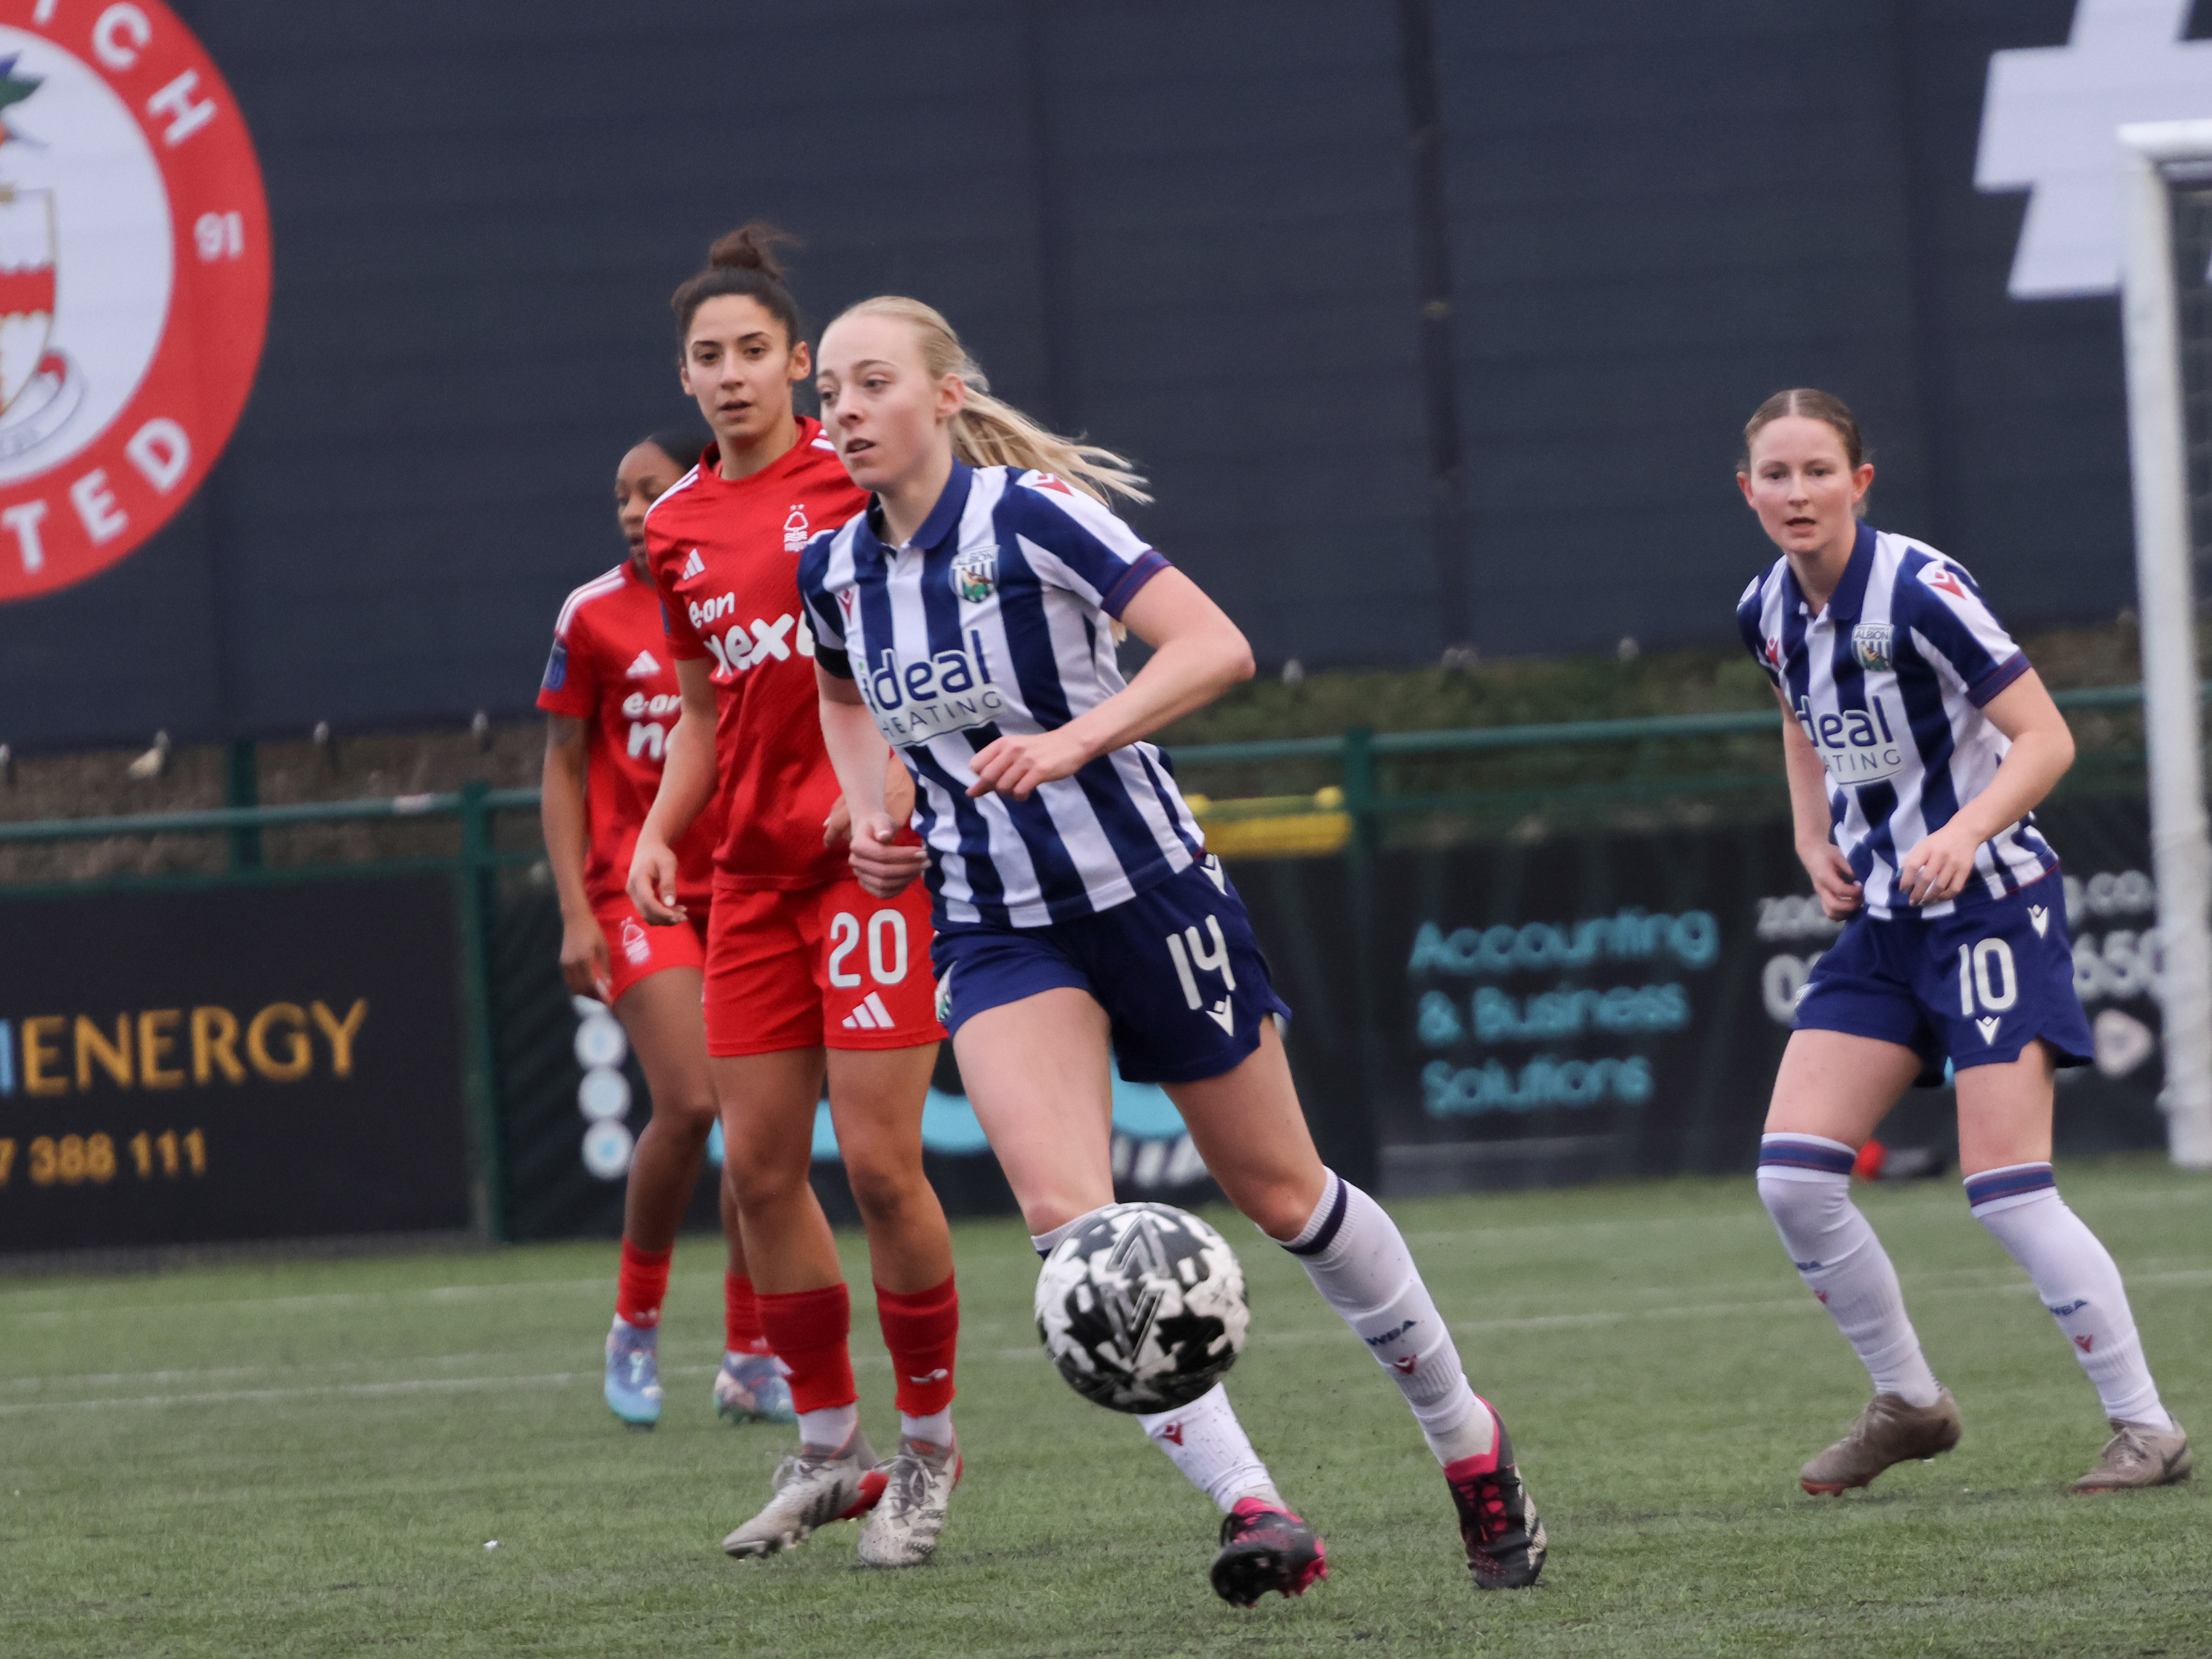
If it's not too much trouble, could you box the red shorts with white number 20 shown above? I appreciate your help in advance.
[705,876,945,1057]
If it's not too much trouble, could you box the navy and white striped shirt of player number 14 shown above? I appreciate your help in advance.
[798,462,1206,927]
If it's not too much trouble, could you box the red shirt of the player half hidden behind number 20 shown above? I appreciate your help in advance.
[538,560,721,907]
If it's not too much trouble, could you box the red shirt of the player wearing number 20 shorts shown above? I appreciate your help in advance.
[646,420,867,891]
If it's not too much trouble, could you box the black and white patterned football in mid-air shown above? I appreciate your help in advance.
[1037,1203,1252,1411]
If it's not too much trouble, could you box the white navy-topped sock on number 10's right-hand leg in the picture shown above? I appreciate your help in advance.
[1966,1163,2174,1429]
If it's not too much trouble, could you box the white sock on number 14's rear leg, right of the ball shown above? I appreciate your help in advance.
[1276,1170,1498,1464]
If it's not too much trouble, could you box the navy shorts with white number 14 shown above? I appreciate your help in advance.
[929,856,1290,1084]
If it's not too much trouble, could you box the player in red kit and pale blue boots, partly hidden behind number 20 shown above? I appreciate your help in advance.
[538,433,792,1429]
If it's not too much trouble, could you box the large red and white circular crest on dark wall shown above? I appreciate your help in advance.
[0,0,270,602]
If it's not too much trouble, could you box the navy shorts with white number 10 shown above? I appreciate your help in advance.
[1796,871,2095,1082]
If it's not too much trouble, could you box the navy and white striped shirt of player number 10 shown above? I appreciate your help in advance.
[1736,524,2059,918]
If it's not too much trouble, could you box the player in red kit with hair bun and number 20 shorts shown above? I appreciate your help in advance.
[630,225,960,1566]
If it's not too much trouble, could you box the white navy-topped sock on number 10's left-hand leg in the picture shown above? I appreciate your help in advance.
[1758,1135,1942,1404]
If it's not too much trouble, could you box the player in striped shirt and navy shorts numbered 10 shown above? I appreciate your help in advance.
[1736,387,2192,1493]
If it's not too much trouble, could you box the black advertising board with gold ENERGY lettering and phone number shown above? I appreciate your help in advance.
[0,876,469,1252]
